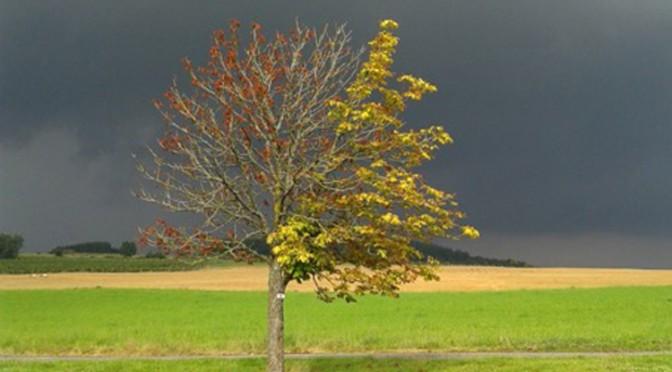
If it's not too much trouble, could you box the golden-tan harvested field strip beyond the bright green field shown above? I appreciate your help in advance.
[0,266,672,292]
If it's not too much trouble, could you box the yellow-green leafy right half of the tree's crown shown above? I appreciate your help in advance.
[268,20,480,299]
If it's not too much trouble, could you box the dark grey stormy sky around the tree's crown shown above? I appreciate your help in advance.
[0,0,672,267]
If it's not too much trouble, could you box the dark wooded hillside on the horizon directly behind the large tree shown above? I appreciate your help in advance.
[246,239,531,267]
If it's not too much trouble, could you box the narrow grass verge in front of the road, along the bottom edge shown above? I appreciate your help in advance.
[0,356,672,372]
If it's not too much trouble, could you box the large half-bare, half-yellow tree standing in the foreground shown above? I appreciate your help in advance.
[138,20,478,371]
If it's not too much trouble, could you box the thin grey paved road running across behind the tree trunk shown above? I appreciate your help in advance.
[0,351,672,362]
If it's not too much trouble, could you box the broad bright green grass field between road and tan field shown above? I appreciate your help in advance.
[0,287,672,355]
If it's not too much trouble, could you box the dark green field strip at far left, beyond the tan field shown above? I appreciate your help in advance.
[0,254,205,274]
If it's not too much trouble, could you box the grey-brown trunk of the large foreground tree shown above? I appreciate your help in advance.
[267,260,286,372]
